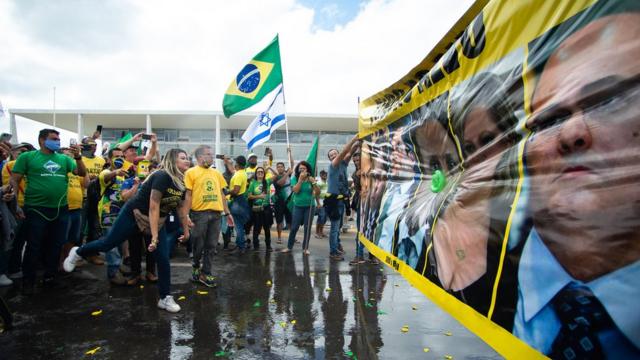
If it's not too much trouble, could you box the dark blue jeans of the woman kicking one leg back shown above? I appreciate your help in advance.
[78,203,174,298]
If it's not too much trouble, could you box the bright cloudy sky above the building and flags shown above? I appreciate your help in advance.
[0,0,472,118]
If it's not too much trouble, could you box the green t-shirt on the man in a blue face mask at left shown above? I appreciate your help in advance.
[13,150,76,209]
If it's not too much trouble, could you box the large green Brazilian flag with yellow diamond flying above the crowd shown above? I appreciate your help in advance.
[222,35,282,118]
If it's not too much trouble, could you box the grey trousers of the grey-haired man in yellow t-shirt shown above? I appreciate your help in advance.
[190,211,222,275]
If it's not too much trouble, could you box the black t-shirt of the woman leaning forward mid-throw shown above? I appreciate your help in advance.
[131,170,185,217]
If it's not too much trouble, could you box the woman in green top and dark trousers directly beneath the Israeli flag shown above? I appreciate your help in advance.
[247,167,273,252]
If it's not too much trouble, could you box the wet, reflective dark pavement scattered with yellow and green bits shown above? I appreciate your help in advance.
[0,226,500,359]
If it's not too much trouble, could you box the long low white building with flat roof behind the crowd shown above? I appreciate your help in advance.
[9,109,358,170]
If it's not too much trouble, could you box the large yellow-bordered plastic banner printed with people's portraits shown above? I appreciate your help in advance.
[359,0,640,359]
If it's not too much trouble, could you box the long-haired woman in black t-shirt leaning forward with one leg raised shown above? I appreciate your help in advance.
[64,149,191,313]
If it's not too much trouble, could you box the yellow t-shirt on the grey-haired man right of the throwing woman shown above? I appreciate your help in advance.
[184,166,227,211]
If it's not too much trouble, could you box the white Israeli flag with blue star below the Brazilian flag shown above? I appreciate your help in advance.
[242,85,287,150]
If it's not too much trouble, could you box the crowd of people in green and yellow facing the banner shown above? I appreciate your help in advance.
[0,129,375,312]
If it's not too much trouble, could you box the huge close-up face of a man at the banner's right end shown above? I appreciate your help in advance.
[526,14,640,256]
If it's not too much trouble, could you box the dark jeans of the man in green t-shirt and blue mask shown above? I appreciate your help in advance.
[22,206,69,284]
